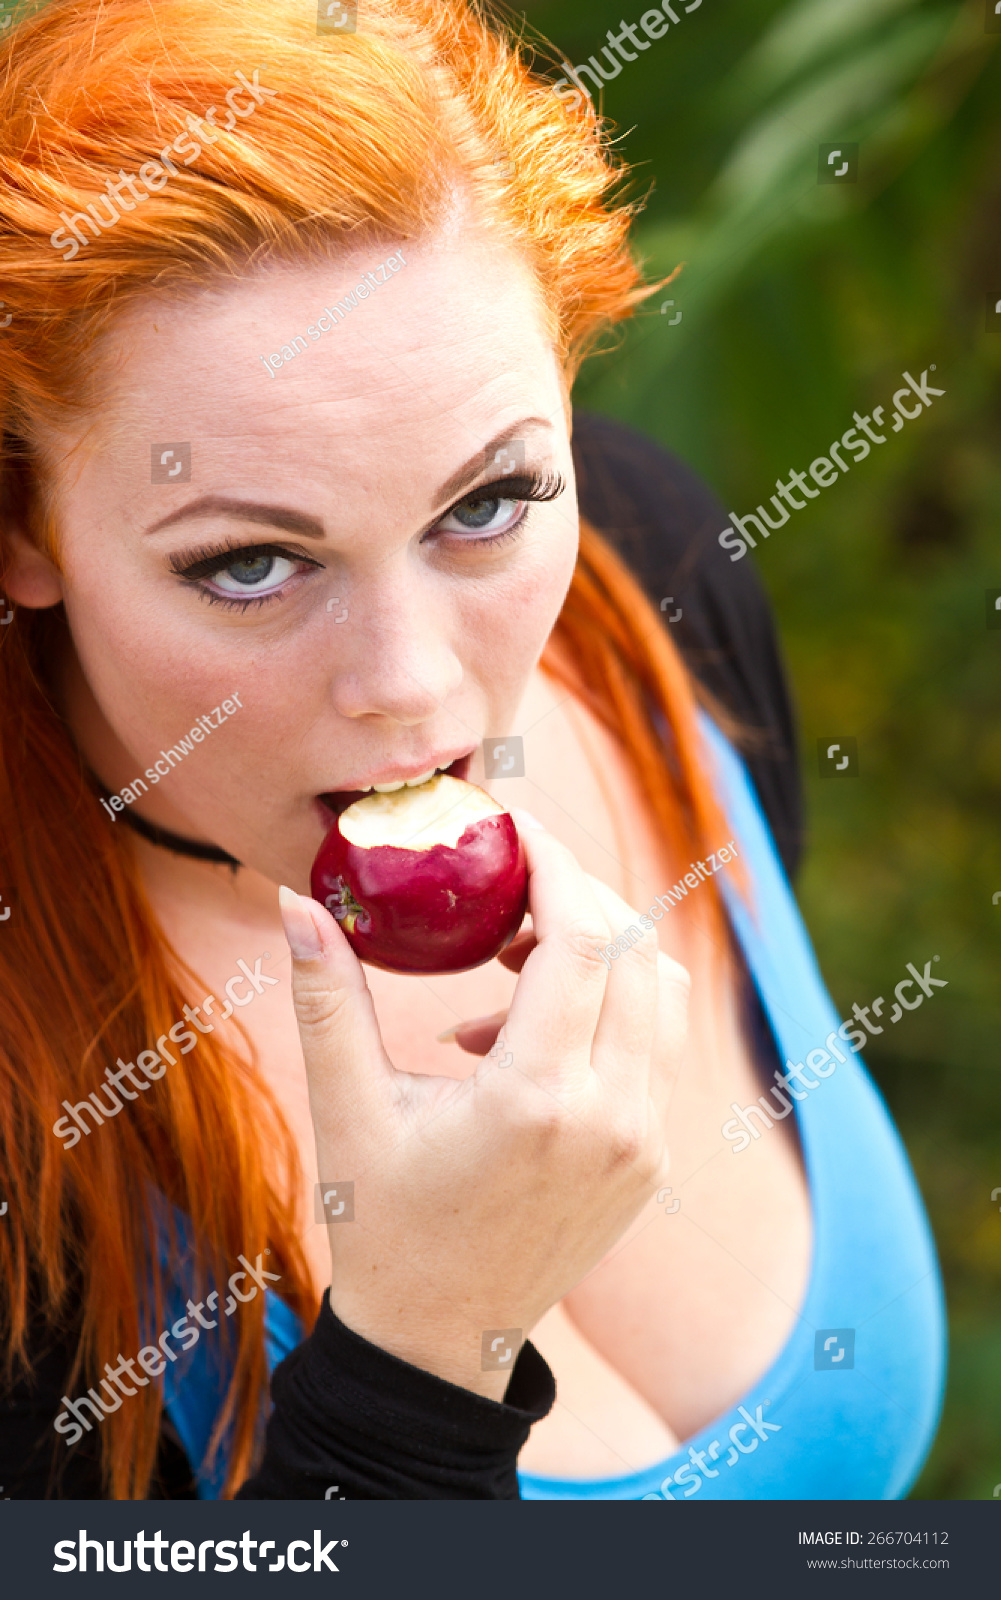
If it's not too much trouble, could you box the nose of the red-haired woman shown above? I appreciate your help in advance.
[331,563,462,726]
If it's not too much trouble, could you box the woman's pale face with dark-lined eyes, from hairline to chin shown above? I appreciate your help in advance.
[8,237,577,888]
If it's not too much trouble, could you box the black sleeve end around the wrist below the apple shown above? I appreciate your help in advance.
[237,1296,556,1499]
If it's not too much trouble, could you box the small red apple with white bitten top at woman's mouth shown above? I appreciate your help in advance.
[310,773,528,973]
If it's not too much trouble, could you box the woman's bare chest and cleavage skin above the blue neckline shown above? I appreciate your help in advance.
[150,675,811,1477]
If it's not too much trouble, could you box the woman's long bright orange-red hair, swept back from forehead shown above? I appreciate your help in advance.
[0,0,726,1498]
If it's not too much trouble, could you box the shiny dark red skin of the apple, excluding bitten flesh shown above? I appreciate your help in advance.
[310,786,528,973]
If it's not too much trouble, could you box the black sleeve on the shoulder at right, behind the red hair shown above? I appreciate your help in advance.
[572,411,803,877]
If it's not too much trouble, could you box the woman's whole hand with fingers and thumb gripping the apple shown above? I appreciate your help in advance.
[281,821,688,1398]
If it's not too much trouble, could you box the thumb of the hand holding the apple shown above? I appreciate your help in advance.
[278,886,393,1139]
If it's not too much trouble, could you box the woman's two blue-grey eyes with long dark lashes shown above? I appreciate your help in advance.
[166,472,566,611]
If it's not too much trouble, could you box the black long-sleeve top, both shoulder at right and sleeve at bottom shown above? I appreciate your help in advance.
[0,414,801,1499]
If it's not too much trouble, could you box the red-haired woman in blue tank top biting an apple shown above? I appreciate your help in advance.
[0,0,942,1498]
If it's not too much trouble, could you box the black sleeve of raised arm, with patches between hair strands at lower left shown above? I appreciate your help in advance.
[0,1296,556,1499]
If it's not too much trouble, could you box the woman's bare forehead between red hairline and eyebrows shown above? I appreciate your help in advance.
[44,240,564,499]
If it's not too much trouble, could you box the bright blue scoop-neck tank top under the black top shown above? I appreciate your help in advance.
[157,718,945,1501]
